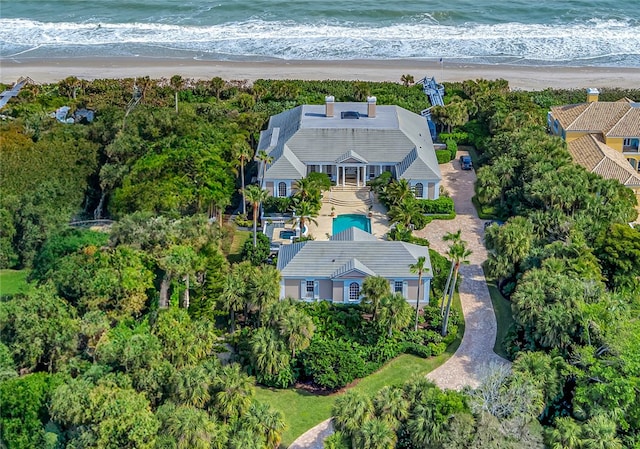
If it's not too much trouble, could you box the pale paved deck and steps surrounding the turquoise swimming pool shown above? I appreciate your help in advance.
[309,192,389,240]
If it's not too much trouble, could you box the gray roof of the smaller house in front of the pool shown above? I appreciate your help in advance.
[278,240,433,279]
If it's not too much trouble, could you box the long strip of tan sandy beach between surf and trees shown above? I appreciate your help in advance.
[0,57,640,90]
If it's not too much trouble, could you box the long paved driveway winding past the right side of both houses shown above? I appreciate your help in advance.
[289,151,509,449]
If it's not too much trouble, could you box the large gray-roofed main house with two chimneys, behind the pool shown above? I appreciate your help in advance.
[258,97,441,199]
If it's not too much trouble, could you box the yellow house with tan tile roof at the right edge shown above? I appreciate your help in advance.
[547,89,640,211]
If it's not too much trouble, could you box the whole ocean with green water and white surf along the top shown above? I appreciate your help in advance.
[0,0,640,67]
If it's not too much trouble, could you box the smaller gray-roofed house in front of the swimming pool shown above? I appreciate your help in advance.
[278,228,433,305]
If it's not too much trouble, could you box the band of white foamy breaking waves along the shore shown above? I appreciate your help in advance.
[0,19,640,65]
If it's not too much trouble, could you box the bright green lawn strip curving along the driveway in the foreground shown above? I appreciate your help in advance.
[256,294,464,447]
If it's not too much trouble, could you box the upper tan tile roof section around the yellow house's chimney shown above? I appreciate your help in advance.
[551,101,637,133]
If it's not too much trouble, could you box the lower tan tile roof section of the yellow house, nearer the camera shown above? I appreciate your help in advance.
[567,134,640,187]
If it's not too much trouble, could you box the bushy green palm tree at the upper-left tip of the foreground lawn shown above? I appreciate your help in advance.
[215,363,255,423]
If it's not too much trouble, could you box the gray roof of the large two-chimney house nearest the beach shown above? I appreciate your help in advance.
[258,103,441,180]
